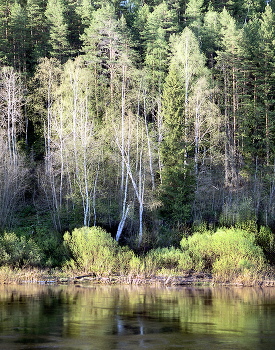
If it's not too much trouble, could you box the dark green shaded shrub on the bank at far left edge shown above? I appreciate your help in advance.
[0,232,44,267]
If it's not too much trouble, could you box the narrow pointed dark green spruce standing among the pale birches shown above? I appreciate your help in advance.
[160,65,194,226]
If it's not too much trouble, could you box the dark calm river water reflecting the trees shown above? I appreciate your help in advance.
[0,285,275,350]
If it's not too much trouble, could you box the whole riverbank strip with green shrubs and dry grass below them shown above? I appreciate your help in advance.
[0,226,275,285]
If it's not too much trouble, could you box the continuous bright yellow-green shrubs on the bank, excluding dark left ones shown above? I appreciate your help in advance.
[64,227,270,279]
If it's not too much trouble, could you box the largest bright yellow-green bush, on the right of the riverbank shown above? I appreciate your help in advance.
[181,228,265,278]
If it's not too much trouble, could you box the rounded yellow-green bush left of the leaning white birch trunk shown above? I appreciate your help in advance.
[64,227,118,275]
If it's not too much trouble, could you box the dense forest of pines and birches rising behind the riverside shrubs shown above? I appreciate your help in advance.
[0,0,275,249]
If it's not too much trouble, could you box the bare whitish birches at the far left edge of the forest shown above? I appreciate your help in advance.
[0,67,27,228]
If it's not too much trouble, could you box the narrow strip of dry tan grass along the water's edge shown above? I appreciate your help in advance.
[0,267,275,287]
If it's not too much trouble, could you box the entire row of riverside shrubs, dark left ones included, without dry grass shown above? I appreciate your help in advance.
[0,225,275,279]
